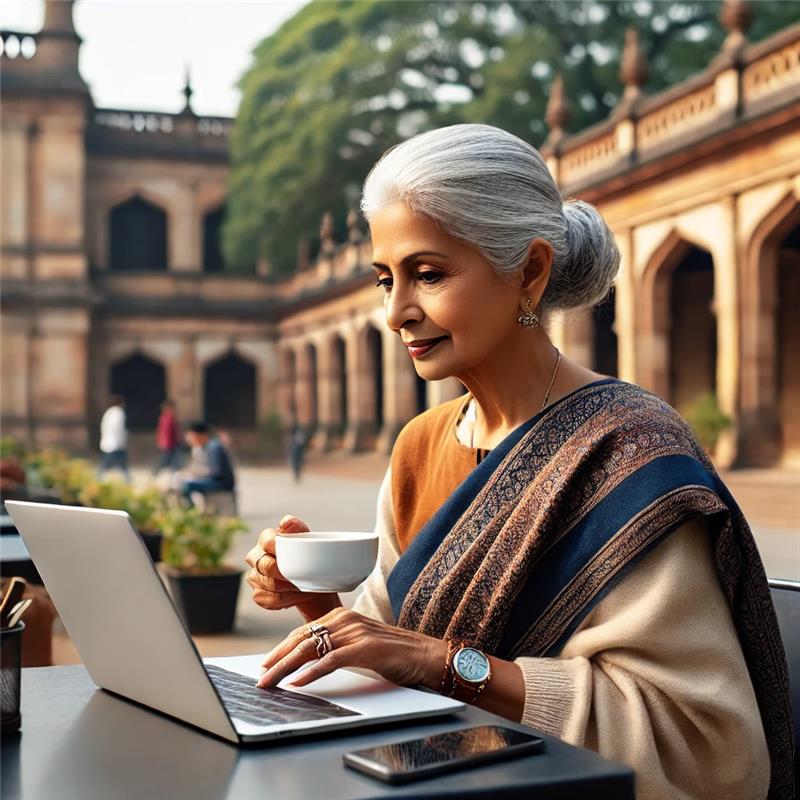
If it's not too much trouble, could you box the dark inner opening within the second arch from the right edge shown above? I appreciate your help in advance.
[669,246,717,413]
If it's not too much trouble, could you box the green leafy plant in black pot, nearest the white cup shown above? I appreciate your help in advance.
[158,506,248,633]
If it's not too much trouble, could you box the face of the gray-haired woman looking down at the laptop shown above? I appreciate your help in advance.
[370,203,522,380]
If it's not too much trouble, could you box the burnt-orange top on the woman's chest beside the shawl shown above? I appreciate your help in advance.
[392,397,486,553]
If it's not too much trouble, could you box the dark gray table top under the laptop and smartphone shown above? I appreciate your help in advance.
[0,666,634,800]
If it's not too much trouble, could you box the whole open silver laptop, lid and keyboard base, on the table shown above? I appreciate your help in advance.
[6,501,464,743]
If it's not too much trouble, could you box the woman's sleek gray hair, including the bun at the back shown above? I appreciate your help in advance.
[361,125,619,311]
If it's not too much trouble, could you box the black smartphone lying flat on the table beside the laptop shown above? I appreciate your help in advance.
[342,725,544,783]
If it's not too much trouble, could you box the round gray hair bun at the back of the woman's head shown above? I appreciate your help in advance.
[542,200,620,310]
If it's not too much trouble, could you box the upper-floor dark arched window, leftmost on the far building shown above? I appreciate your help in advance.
[109,197,167,271]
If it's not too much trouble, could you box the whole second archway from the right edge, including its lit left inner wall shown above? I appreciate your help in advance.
[638,233,717,413]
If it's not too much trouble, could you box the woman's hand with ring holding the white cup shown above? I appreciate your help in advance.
[245,516,341,622]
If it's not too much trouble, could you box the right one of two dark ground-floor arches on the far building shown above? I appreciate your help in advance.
[203,353,257,428]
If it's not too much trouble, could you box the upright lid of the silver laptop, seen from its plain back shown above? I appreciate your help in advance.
[6,500,239,743]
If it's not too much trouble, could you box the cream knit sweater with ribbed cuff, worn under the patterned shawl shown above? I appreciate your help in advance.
[354,472,770,800]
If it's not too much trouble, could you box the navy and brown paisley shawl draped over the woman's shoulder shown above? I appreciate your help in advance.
[387,380,794,798]
